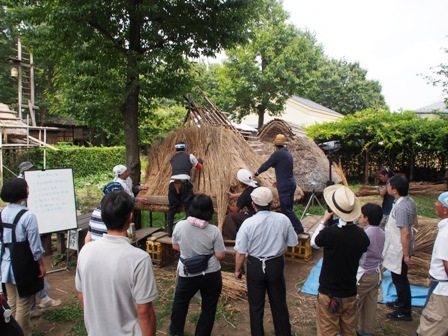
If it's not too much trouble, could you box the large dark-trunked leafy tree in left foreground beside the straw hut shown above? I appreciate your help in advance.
[4,0,262,181]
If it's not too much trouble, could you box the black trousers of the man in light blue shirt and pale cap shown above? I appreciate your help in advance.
[247,256,291,336]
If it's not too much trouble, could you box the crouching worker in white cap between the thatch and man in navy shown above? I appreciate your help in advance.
[222,169,258,240]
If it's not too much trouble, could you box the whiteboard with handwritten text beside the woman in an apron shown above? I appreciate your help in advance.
[25,169,77,234]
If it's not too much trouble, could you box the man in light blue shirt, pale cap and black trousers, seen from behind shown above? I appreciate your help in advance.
[235,187,298,335]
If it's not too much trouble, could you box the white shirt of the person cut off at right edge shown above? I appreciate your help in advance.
[429,218,448,296]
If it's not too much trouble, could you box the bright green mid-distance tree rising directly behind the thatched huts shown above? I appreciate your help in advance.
[215,0,323,128]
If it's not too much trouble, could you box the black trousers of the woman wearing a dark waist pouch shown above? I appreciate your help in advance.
[170,271,222,336]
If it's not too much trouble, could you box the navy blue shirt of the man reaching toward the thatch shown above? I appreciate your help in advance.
[258,147,297,192]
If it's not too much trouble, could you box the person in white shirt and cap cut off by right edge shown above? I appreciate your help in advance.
[417,191,448,336]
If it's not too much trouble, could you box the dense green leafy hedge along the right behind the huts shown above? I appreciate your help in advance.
[306,109,448,184]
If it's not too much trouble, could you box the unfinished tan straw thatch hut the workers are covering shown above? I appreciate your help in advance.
[137,124,278,228]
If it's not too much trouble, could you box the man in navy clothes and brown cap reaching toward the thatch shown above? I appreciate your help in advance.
[254,134,303,234]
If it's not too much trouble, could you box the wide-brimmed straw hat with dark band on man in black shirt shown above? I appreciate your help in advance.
[324,184,361,222]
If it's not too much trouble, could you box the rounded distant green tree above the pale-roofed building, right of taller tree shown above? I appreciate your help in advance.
[309,59,388,114]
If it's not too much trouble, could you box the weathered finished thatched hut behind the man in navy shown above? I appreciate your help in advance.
[258,119,342,192]
